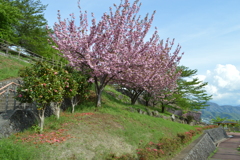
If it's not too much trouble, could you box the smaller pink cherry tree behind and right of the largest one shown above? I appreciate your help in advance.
[118,40,181,104]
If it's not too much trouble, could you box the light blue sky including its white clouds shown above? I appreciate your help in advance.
[41,0,240,105]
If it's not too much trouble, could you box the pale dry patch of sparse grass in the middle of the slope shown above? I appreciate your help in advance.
[42,114,136,160]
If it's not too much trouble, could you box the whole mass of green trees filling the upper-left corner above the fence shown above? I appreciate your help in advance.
[0,0,61,58]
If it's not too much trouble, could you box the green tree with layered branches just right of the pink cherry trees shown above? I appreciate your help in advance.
[143,66,212,113]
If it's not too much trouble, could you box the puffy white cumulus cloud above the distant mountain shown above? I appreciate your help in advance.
[203,64,240,105]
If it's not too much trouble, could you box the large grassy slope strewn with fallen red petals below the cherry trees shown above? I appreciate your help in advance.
[0,87,203,160]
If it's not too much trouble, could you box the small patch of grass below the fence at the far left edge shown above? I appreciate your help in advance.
[0,55,30,81]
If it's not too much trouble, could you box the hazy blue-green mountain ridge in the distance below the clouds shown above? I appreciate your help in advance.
[201,102,240,120]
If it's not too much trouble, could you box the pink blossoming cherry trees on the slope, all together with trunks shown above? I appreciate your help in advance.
[50,0,182,107]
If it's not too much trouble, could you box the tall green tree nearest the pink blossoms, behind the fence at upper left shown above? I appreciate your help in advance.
[1,0,59,58]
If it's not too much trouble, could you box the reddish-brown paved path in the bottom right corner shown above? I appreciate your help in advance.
[211,132,240,160]
